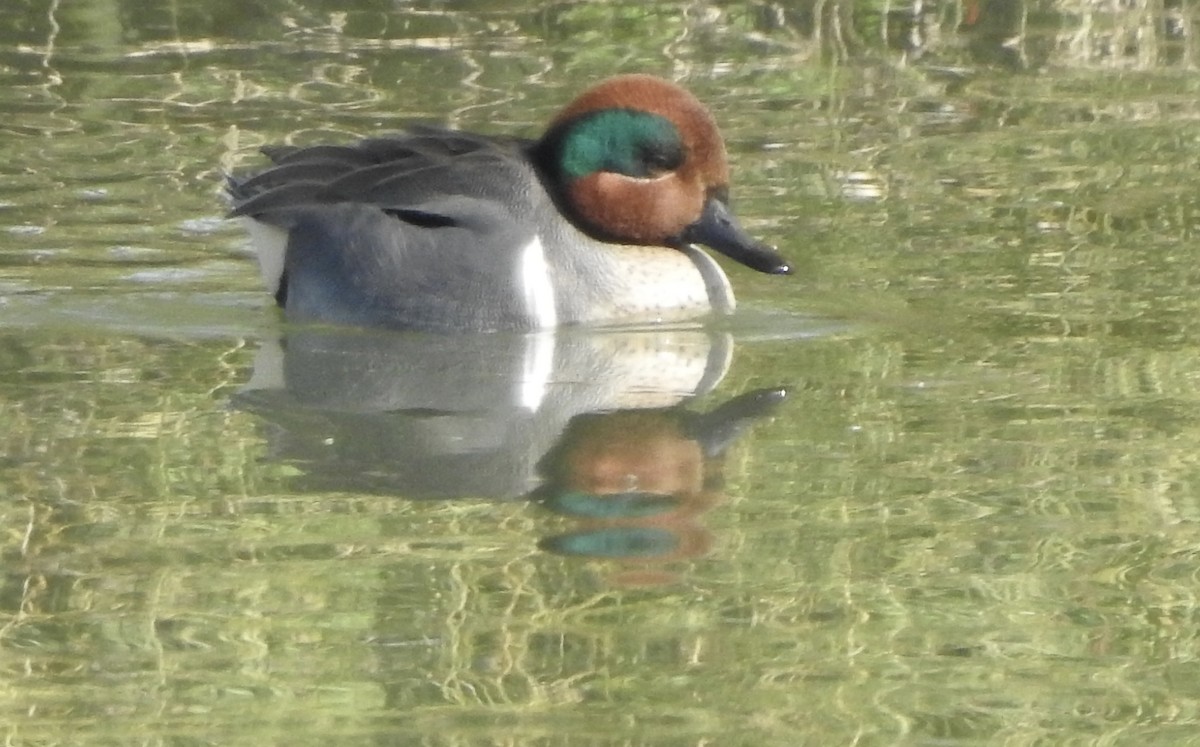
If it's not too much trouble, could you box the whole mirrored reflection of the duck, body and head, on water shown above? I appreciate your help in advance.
[236,328,784,576]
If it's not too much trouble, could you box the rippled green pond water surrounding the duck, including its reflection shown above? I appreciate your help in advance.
[0,0,1200,746]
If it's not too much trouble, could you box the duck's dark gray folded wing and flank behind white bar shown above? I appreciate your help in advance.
[229,131,541,329]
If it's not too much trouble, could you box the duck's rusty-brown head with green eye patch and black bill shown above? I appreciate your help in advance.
[534,74,792,275]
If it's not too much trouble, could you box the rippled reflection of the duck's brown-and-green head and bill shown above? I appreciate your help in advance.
[532,389,785,584]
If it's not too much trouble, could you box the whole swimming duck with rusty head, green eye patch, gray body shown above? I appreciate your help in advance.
[227,74,792,331]
